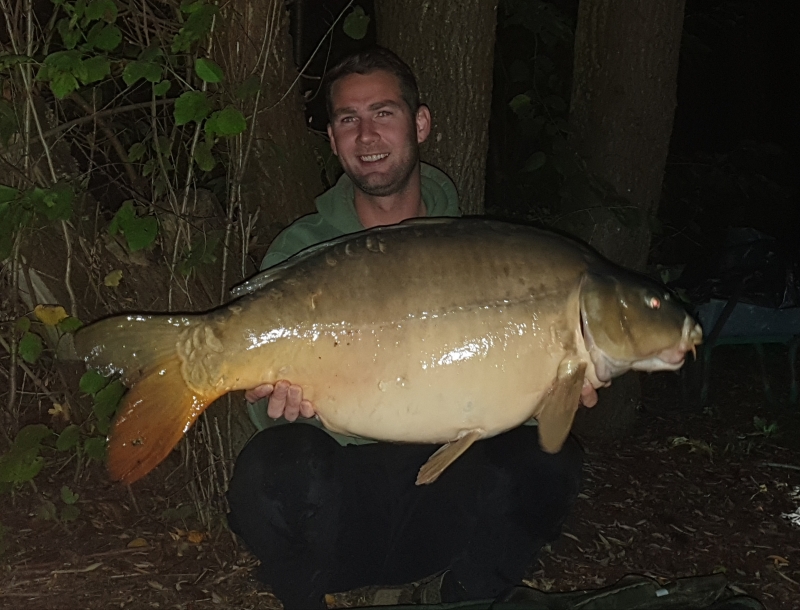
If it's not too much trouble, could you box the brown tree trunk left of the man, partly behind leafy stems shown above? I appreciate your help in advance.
[206,0,328,457]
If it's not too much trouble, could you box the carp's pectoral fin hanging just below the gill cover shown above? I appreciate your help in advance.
[536,359,586,453]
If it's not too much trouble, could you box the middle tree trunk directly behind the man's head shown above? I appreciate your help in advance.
[375,0,497,214]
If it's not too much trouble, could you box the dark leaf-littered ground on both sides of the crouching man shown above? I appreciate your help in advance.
[0,347,800,610]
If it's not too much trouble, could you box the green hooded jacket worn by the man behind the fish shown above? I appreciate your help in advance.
[247,163,461,445]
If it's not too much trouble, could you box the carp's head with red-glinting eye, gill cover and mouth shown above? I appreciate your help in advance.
[580,271,703,382]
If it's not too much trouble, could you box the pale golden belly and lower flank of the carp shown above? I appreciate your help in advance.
[231,303,575,443]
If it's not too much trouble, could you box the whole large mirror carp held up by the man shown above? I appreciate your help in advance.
[75,219,702,483]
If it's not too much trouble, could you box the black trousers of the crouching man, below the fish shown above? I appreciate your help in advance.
[228,424,583,609]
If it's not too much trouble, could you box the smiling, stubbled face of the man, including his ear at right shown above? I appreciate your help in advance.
[328,70,430,197]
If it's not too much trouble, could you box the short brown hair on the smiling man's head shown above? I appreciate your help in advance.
[325,46,420,118]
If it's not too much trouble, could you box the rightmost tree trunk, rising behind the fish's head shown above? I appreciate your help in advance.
[560,0,684,436]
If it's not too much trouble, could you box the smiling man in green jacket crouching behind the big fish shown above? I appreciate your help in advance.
[228,48,582,610]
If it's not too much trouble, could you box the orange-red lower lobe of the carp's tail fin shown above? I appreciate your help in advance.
[108,356,219,483]
